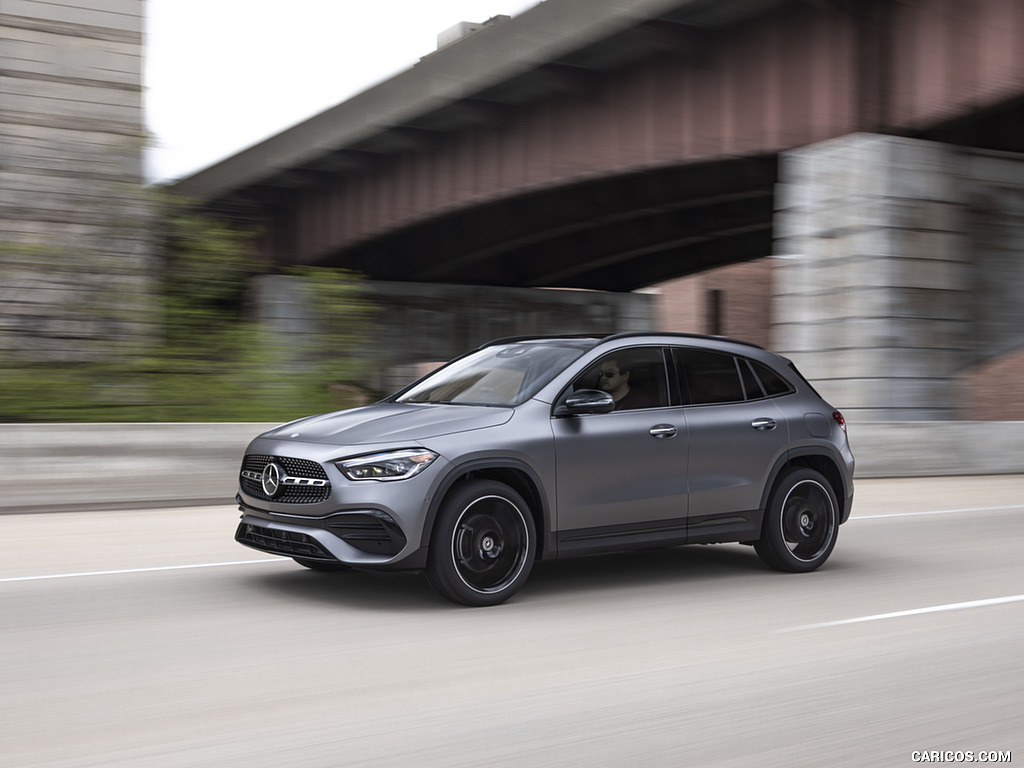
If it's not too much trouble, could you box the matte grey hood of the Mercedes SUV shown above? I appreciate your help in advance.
[261,402,513,445]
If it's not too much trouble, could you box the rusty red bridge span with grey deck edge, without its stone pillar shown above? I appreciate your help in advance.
[176,0,1024,291]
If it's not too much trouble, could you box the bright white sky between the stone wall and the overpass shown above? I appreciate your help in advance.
[143,0,540,181]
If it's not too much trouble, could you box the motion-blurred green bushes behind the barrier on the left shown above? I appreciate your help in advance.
[0,192,373,422]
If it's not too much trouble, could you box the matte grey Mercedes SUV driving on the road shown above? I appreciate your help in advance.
[236,333,854,605]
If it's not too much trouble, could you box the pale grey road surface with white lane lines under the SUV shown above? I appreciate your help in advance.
[0,476,1024,768]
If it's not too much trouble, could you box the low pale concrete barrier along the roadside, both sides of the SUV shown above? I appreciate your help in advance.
[0,422,1024,513]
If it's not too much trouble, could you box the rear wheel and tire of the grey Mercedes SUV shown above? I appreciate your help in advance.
[754,467,839,573]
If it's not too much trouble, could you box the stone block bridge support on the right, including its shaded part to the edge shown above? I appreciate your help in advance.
[771,134,1024,421]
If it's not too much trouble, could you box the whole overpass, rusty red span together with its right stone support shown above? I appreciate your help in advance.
[176,0,1024,419]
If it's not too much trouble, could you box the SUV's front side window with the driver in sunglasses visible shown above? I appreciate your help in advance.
[572,347,669,411]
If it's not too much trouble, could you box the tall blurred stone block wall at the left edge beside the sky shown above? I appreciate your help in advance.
[0,0,150,360]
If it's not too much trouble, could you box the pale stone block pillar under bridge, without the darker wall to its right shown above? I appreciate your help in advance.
[771,134,974,421]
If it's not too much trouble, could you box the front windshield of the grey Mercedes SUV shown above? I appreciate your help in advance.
[394,339,595,406]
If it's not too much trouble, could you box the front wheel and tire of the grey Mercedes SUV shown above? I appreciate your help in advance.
[426,480,537,606]
